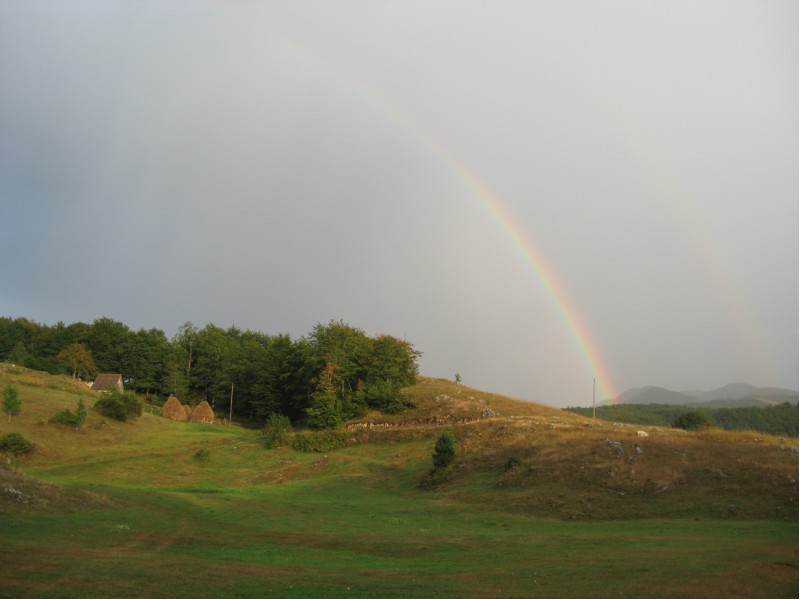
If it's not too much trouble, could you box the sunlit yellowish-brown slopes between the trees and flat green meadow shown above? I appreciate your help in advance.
[0,368,798,519]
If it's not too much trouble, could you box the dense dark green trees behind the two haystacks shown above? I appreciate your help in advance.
[0,317,421,427]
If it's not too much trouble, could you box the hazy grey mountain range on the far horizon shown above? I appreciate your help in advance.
[604,383,798,408]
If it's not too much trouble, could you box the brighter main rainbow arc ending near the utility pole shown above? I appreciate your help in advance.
[276,34,619,400]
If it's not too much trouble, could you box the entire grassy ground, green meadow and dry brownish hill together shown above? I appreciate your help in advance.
[0,365,798,597]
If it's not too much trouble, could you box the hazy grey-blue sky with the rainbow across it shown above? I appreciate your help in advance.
[0,0,799,406]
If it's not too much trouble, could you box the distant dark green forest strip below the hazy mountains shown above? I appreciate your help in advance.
[565,402,798,437]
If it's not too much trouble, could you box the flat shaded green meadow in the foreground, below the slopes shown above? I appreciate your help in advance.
[0,468,798,597]
